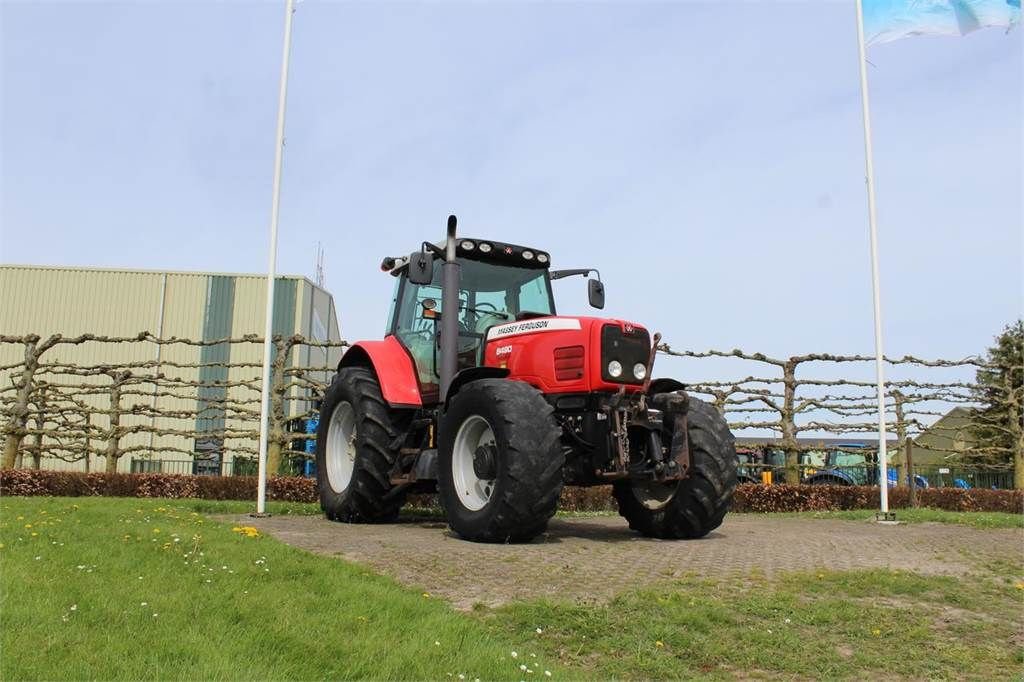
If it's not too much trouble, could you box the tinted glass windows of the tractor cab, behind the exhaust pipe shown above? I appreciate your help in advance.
[390,258,555,397]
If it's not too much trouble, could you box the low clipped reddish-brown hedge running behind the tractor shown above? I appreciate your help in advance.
[0,469,1024,514]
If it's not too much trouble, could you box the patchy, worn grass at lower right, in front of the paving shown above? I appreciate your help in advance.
[484,570,1024,680]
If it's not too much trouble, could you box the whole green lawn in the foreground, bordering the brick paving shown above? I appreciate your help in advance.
[0,498,1024,680]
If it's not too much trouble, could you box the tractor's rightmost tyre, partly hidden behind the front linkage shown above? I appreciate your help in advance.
[611,397,738,540]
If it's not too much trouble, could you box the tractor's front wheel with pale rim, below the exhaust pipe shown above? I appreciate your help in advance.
[437,379,565,543]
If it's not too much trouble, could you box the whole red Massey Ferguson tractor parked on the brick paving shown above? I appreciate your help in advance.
[316,216,737,542]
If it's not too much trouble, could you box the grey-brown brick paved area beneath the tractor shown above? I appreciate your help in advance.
[230,514,1024,608]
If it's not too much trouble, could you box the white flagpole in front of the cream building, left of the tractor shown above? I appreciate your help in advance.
[256,0,295,514]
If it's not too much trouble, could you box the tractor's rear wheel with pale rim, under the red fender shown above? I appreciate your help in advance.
[316,367,408,523]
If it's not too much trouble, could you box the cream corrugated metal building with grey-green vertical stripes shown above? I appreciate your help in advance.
[0,265,341,470]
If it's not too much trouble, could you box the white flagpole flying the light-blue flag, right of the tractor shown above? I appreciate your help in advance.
[857,0,889,514]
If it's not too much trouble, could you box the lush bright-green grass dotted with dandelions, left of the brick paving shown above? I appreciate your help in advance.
[0,498,548,680]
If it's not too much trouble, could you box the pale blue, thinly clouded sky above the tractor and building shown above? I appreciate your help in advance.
[0,0,1024,372]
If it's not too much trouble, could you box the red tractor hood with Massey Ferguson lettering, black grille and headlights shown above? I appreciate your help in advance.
[483,315,650,393]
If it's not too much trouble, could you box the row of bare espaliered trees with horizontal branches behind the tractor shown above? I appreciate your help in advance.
[0,332,1024,487]
